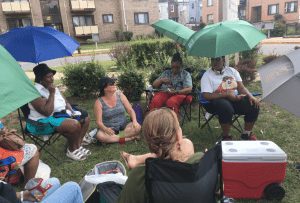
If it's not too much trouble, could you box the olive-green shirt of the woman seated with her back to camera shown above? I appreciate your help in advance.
[118,152,203,203]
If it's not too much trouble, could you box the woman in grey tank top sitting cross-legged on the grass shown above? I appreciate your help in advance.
[94,77,141,143]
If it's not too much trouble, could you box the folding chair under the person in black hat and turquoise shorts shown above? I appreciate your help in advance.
[18,104,61,160]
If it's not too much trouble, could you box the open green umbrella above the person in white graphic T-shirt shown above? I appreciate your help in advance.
[186,20,266,57]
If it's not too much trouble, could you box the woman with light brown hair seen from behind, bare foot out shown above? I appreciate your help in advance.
[118,108,203,203]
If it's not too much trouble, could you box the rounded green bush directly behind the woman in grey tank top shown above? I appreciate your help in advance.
[118,68,145,102]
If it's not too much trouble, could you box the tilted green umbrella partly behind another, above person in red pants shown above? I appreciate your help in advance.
[151,19,195,45]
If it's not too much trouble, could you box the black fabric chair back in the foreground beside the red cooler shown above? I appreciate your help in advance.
[145,144,223,203]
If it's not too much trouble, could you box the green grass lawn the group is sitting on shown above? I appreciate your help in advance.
[6,80,300,203]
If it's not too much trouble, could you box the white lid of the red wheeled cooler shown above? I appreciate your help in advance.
[222,140,287,162]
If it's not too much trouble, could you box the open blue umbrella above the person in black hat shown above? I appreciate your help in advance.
[0,26,79,63]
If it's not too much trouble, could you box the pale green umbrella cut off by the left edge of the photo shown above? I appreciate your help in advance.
[0,45,40,118]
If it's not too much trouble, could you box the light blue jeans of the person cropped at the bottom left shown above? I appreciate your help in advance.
[24,178,83,203]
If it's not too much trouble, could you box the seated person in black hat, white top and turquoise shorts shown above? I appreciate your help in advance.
[26,64,91,161]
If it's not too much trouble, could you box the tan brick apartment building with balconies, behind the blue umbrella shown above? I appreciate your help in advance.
[0,0,159,41]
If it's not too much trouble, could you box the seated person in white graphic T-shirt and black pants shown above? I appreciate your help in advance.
[201,57,259,140]
